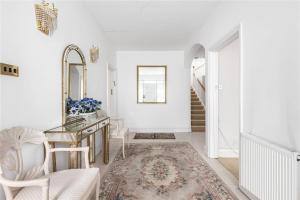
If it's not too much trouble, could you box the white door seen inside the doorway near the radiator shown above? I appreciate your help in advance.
[218,39,240,157]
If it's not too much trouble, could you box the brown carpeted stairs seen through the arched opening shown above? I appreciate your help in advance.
[191,89,205,132]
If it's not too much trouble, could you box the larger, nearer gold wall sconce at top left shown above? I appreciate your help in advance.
[34,0,57,35]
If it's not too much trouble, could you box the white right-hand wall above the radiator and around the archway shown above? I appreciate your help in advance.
[186,2,300,151]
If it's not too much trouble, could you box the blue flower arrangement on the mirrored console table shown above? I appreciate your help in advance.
[66,97,102,116]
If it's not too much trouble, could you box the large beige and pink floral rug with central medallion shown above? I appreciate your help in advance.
[100,142,237,200]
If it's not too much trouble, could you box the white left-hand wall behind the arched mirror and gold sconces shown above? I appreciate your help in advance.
[0,1,114,200]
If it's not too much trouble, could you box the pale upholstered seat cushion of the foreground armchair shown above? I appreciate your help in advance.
[14,168,100,200]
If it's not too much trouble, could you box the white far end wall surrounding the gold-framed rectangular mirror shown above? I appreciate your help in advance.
[117,51,190,132]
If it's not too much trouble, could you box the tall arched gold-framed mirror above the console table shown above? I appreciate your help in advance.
[62,44,87,124]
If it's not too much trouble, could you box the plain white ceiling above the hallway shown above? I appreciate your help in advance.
[85,0,217,50]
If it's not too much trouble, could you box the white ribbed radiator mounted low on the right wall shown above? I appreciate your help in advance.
[240,134,300,200]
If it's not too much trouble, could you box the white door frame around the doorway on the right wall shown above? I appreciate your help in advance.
[206,24,244,158]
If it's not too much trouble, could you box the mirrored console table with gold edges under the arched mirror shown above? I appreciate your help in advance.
[44,117,110,171]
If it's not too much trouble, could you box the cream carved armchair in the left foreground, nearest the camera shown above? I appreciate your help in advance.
[0,127,100,200]
